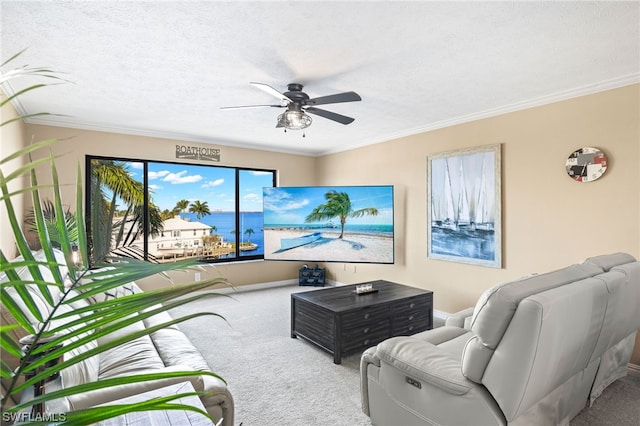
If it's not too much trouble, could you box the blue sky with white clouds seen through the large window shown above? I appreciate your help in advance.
[129,162,272,212]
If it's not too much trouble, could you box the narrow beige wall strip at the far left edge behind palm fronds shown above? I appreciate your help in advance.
[0,95,26,259]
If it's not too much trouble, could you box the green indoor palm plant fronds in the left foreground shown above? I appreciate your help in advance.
[0,150,227,419]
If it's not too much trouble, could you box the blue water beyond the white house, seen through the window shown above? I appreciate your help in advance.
[181,212,264,256]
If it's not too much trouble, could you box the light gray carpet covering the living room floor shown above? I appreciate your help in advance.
[172,286,640,426]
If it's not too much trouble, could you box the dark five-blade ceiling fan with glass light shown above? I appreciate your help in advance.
[221,82,362,136]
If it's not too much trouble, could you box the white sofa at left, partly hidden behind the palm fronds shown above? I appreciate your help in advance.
[0,252,234,426]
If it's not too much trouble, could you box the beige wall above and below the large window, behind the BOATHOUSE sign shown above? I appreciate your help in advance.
[18,125,316,288]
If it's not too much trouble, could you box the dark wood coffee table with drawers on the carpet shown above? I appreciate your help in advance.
[291,280,433,364]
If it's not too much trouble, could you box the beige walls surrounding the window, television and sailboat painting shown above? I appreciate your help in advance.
[2,85,640,364]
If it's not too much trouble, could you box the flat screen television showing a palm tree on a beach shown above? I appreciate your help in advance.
[263,185,394,263]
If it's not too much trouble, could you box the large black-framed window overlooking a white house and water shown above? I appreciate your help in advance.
[86,156,276,262]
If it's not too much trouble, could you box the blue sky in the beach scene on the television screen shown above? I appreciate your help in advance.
[264,186,393,225]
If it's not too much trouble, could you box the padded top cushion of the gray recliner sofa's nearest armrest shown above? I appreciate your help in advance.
[376,336,474,395]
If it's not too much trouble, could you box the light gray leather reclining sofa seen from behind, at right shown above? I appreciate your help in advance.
[361,253,640,426]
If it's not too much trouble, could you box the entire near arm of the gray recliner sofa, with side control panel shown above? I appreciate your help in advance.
[361,336,507,426]
